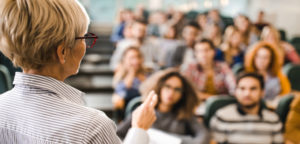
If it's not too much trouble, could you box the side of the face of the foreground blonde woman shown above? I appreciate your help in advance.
[65,36,86,76]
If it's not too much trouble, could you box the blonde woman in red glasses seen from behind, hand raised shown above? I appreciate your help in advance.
[0,0,157,144]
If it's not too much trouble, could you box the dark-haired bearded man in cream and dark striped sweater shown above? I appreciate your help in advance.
[210,73,283,144]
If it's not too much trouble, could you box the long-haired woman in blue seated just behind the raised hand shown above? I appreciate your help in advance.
[112,47,146,109]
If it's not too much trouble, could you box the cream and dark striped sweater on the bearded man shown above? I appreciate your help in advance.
[210,104,283,144]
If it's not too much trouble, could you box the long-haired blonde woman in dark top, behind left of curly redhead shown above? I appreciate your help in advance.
[215,26,245,67]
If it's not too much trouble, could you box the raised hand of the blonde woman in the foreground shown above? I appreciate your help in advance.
[131,91,158,130]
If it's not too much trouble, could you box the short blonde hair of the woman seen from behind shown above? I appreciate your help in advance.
[0,0,90,69]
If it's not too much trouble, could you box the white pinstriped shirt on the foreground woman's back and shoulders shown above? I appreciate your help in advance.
[0,73,146,144]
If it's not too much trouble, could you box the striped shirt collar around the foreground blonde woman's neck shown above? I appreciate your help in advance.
[13,72,84,105]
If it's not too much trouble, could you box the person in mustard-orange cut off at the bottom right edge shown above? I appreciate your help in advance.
[284,93,300,144]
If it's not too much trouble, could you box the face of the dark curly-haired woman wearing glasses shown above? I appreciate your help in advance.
[160,76,183,107]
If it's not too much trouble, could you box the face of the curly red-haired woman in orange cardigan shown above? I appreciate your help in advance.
[255,47,272,71]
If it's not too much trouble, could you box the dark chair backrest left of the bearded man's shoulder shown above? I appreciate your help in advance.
[204,95,237,128]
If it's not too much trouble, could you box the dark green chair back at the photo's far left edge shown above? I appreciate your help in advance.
[0,64,12,94]
